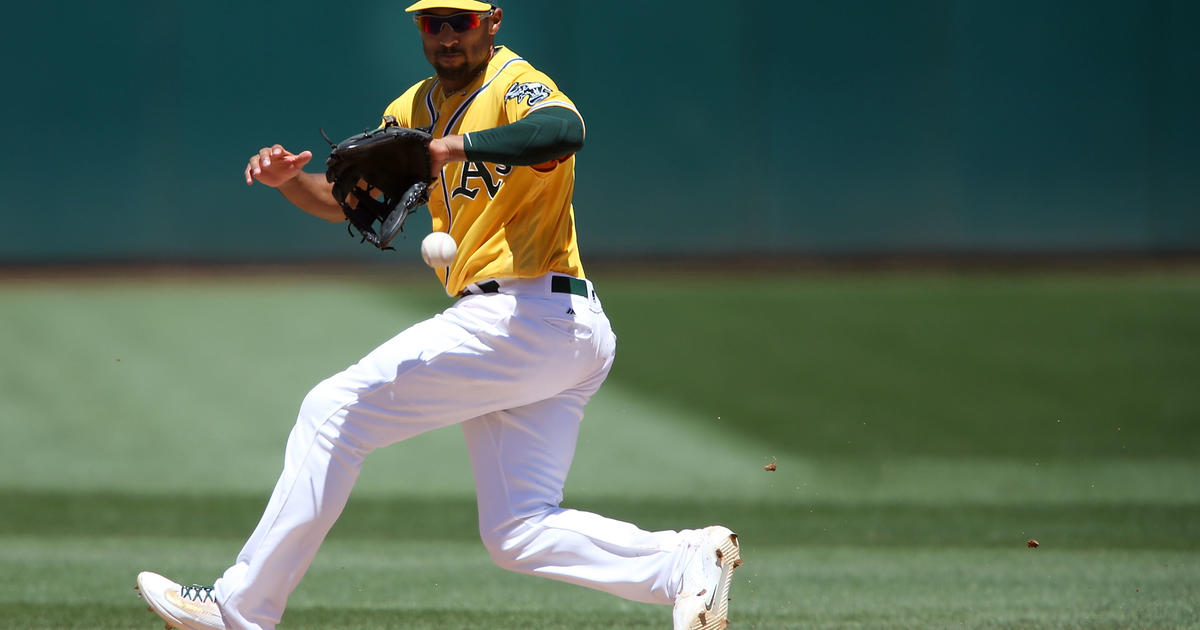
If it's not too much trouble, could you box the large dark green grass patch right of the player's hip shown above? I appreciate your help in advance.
[602,270,1200,457]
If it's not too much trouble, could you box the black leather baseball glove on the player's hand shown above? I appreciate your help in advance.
[322,116,433,250]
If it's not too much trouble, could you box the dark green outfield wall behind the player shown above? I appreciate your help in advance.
[0,0,1200,263]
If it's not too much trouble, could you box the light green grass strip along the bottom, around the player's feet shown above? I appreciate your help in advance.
[0,538,1200,630]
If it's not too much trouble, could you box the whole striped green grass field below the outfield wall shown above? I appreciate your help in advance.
[0,269,1200,630]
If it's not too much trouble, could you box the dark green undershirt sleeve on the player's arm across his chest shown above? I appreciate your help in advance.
[463,107,583,167]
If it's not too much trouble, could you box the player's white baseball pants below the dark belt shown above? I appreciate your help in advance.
[215,275,685,630]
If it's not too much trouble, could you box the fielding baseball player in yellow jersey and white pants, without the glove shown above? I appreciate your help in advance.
[138,0,742,630]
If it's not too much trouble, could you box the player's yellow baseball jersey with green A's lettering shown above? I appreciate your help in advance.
[384,46,584,295]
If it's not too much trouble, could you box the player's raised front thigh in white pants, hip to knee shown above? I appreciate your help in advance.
[329,296,612,448]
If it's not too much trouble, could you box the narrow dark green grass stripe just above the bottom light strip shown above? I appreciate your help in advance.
[0,491,1200,550]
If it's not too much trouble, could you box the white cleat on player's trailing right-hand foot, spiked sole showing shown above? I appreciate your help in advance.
[674,526,742,630]
